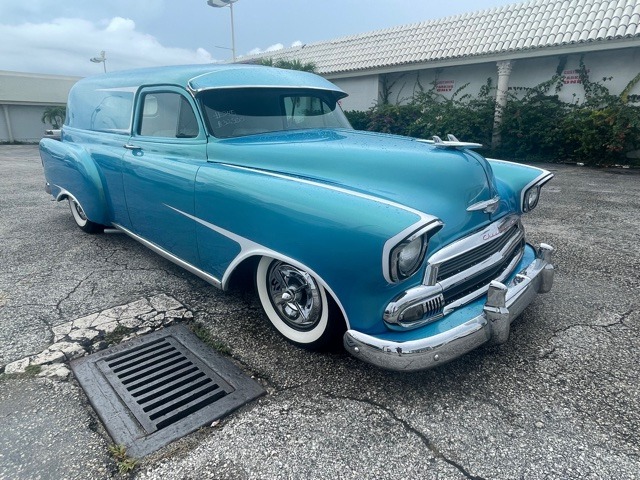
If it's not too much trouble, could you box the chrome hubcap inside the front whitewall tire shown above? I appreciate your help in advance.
[267,261,322,331]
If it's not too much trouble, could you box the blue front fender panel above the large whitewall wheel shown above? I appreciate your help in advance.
[195,163,437,330]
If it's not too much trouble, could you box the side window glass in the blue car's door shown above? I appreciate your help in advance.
[138,92,199,138]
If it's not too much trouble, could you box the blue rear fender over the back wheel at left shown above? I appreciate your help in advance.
[40,138,111,225]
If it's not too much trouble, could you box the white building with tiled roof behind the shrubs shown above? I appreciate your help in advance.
[240,0,640,110]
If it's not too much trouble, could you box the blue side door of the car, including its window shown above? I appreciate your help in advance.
[123,87,207,265]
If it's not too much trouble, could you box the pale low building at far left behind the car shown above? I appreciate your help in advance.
[0,71,80,142]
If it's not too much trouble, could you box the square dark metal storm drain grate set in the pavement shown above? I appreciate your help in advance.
[71,325,264,457]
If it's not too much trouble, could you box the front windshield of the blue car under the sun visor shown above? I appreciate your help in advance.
[199,88,351,138]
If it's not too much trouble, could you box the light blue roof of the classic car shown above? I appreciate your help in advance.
[74,64,346,96]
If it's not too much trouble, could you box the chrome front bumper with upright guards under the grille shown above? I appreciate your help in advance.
[344,243,554,371]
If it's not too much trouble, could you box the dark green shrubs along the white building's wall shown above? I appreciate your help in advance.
[347,62,640,165]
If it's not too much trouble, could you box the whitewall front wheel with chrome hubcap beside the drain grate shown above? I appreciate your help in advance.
[256,257,344,350]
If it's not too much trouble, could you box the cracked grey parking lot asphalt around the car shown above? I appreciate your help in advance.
[0,146,640,479]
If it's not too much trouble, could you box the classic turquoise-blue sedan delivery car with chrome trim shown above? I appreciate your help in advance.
[40,65,553,370]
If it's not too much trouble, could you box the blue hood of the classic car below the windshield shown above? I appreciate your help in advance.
[209,129,500,246]
